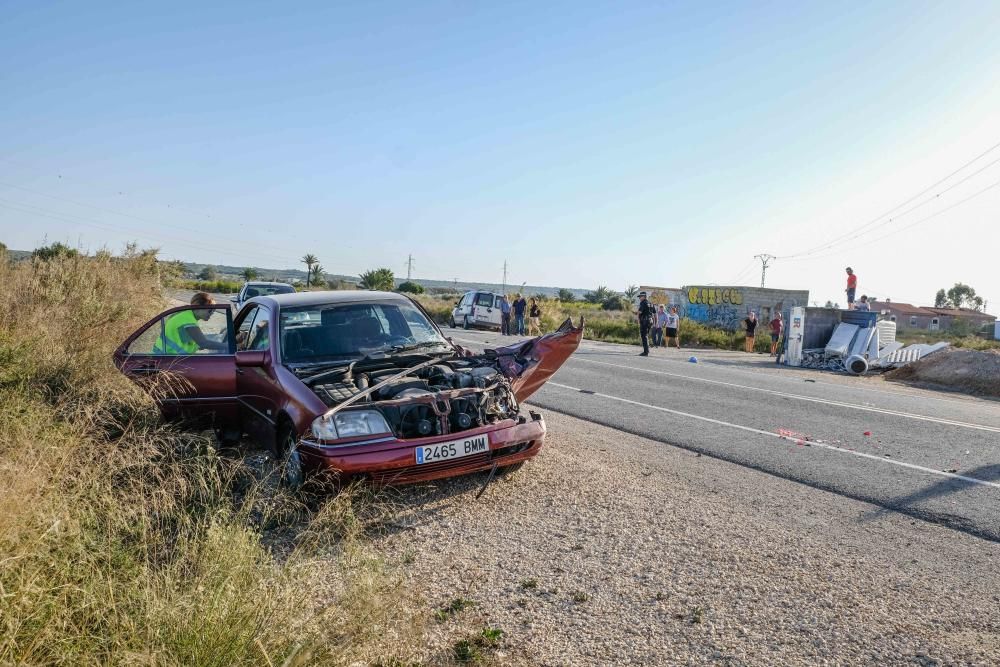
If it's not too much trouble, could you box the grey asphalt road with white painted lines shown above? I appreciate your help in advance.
[445,329,1000,541]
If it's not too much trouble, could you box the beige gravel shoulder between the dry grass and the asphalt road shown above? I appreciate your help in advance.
[376,412,1000,665]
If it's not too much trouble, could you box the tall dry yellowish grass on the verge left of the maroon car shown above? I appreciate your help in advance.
[0,253,423,666]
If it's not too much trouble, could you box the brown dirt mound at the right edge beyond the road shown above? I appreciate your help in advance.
[885,348,1000,398]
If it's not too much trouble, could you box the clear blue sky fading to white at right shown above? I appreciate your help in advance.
[0,2,1000,310]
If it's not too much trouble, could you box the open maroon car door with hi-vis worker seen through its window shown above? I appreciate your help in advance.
[114,304,239,427]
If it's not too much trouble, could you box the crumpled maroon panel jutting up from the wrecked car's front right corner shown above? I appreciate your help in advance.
[495,318,583,402]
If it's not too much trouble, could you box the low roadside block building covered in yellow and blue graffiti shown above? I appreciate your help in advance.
[640,285,809,331]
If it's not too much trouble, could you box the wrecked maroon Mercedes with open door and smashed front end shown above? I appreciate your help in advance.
[115,291,583,486]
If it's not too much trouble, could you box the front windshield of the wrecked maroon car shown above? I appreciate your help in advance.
[280,302,448,363]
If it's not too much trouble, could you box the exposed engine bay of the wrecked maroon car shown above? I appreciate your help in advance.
[311,357,518,438]
